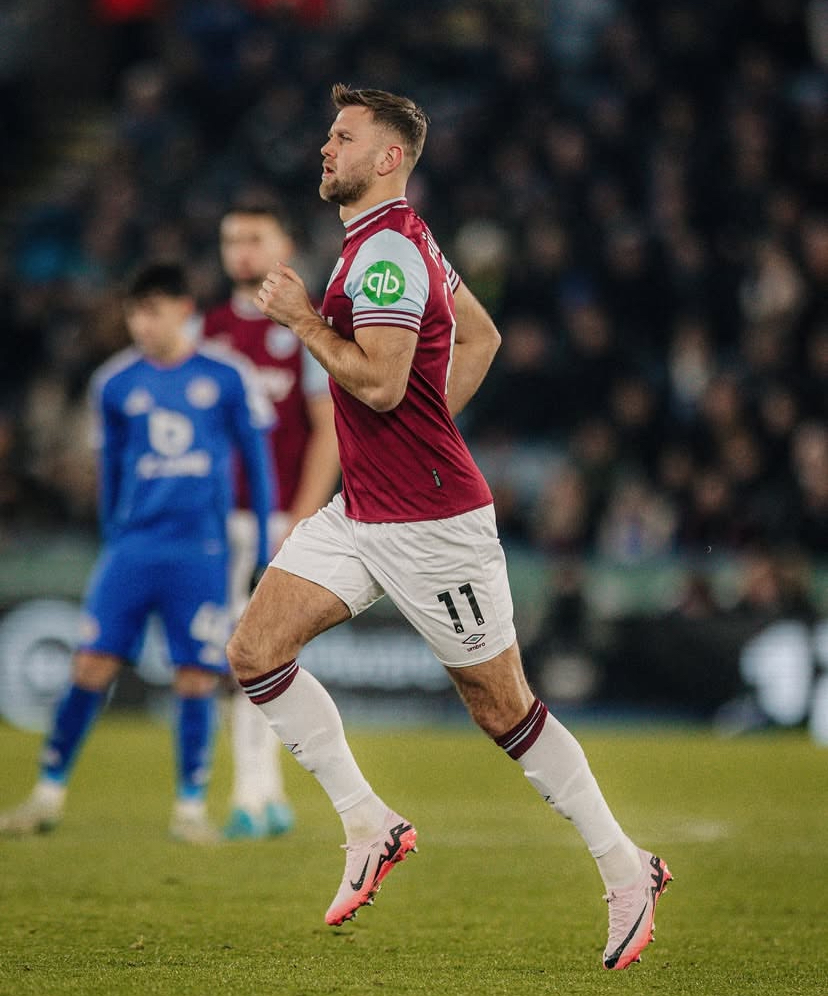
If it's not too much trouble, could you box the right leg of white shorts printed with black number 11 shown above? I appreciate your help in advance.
[359,506,515,667]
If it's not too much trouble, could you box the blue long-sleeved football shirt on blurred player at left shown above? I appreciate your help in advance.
[91,345,273,564]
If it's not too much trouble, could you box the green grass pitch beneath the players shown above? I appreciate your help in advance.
[0,715,828,996]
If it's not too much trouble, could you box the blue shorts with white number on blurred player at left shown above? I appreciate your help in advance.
[78,537,229,671]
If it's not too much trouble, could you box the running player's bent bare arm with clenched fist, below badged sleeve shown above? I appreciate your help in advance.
[256,263,417,412]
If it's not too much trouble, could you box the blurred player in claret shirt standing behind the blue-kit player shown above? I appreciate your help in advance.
[203,205,339,838]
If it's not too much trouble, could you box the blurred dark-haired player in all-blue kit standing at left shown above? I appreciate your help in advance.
[0,264,272,843]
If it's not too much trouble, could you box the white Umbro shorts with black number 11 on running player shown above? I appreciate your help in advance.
[271,494,515,667]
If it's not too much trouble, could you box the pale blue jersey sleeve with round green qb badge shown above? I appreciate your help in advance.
[345,229,429,333]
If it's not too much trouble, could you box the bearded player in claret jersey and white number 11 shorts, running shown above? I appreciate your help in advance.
[228,84,671,969]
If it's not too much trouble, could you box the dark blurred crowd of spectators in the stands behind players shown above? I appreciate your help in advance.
[0,0,828,584]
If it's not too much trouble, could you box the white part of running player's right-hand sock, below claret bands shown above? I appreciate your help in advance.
[517,713,641,889]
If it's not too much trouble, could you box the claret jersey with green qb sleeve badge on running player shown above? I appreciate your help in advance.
[321,198,492,522]
